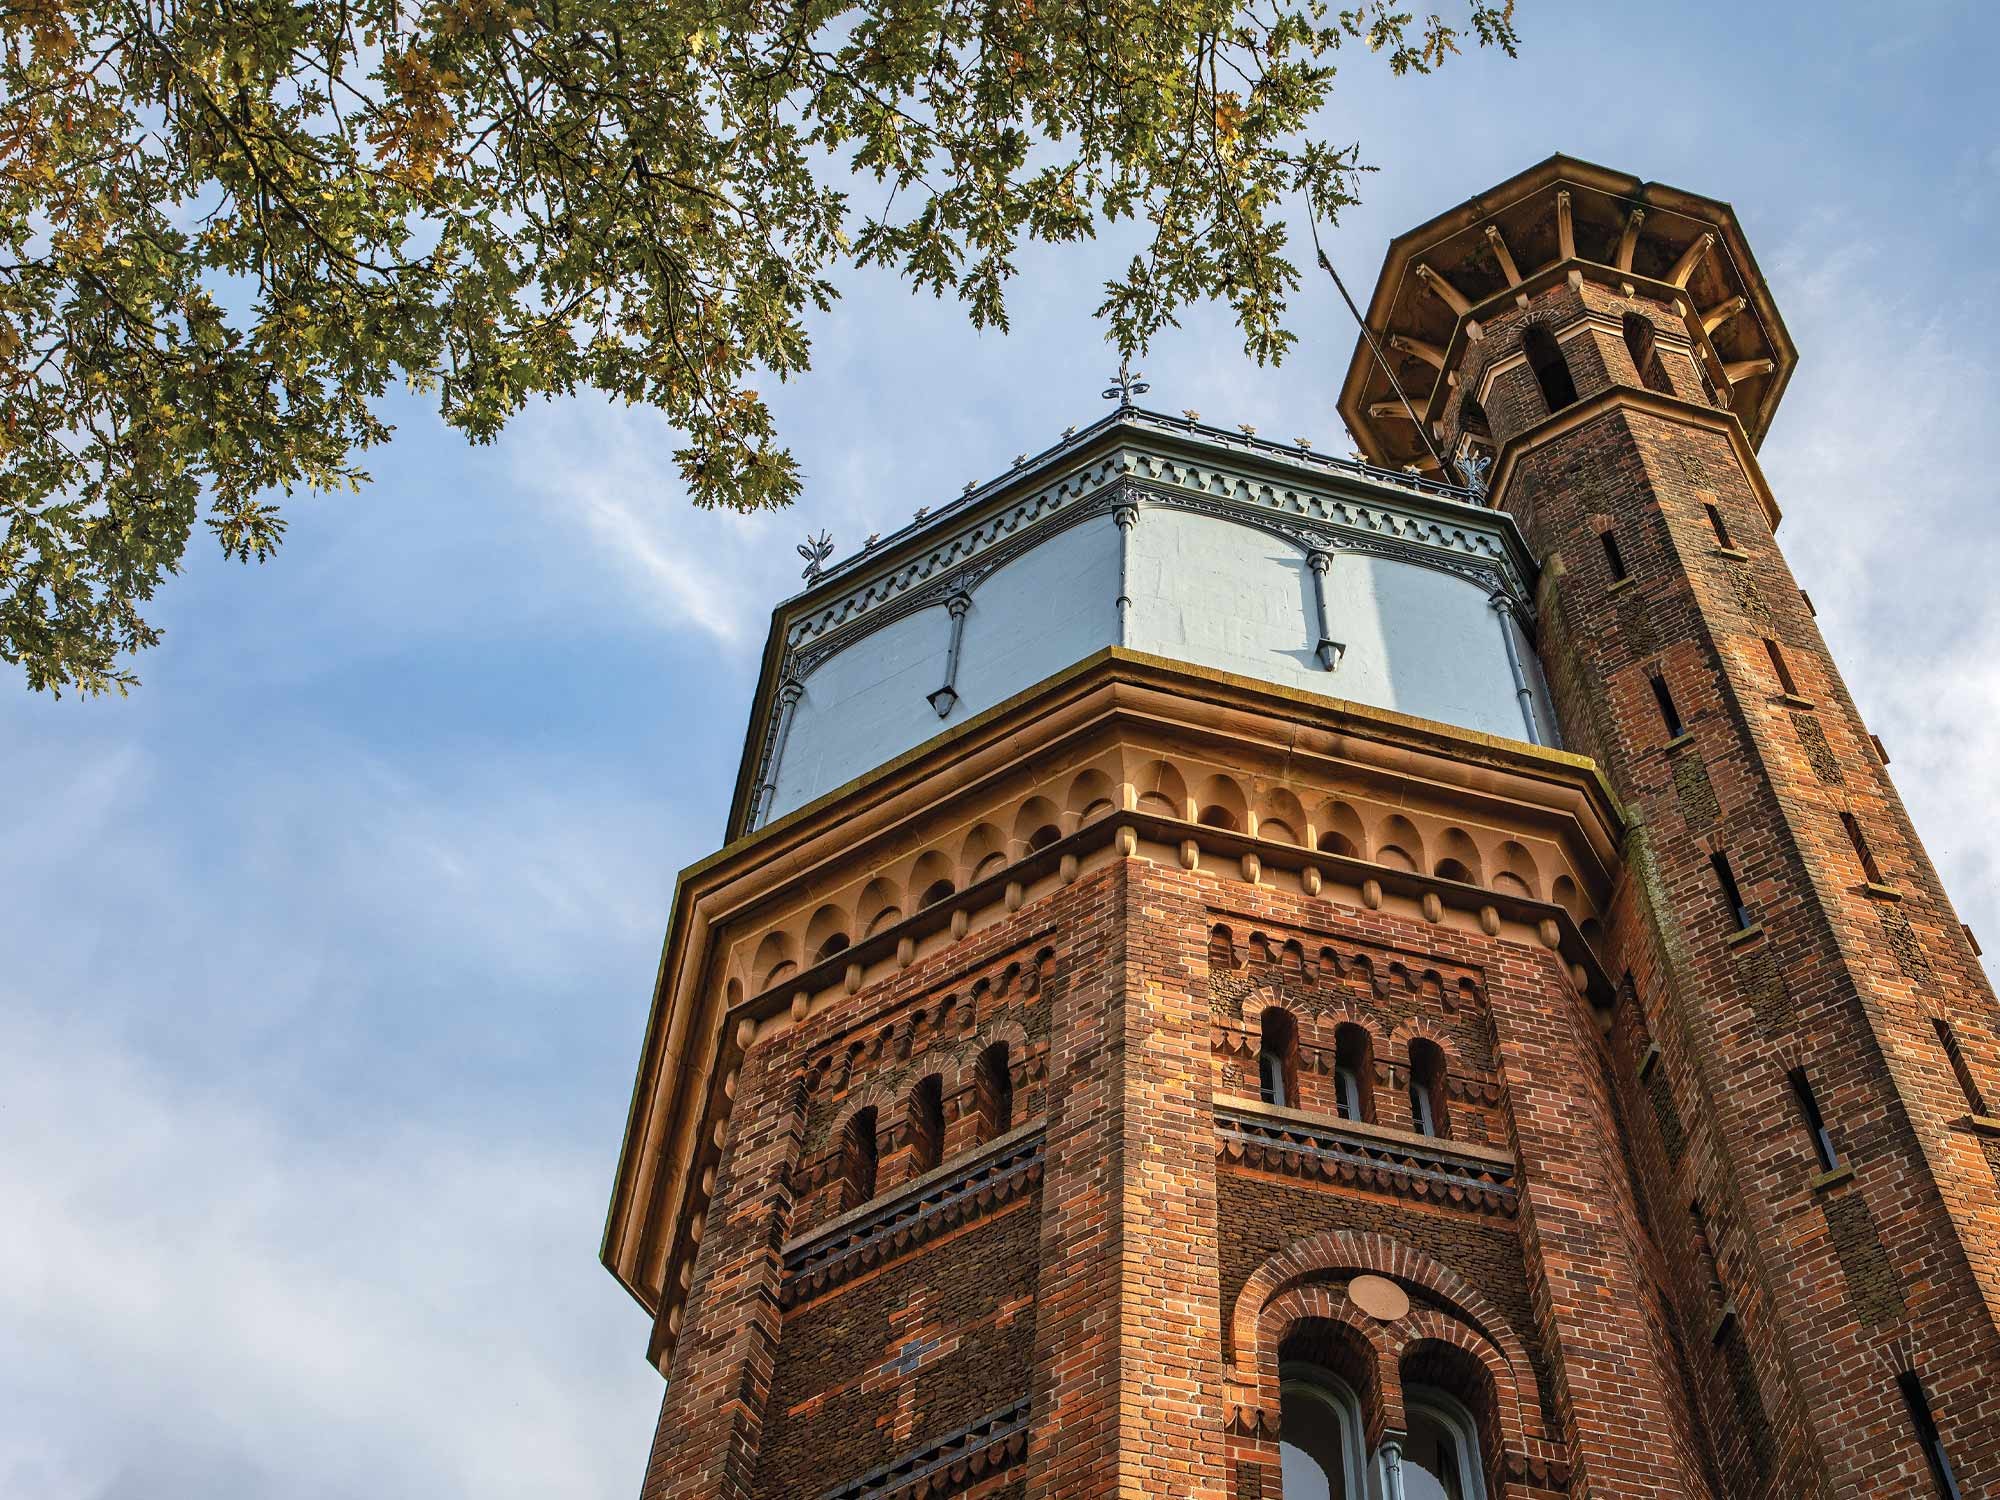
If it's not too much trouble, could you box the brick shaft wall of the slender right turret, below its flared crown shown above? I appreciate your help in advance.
[1480,288,2000,1496]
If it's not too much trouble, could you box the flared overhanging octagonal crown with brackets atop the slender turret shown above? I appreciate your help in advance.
[1340,156,1798,468]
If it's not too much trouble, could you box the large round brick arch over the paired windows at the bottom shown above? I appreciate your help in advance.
[1228,1230,1548,1450]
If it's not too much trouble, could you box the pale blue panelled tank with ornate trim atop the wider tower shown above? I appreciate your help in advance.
[730,404,1556,838]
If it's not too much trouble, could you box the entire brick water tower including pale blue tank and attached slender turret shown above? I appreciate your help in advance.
[604,158,2000,1500]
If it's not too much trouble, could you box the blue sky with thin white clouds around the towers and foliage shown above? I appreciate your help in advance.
[0,0,2000,1500]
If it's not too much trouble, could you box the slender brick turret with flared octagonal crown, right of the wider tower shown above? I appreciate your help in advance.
[1340,156,2000,1496]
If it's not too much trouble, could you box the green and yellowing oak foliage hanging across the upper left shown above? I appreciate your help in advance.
[0,0,1514,692]
